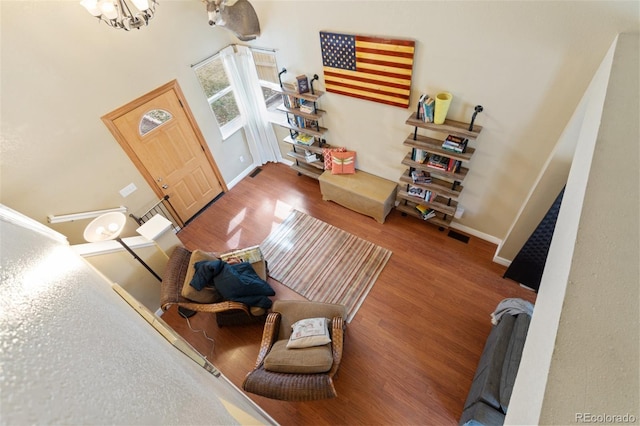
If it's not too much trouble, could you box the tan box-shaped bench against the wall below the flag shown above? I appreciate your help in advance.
[318,170,398,223]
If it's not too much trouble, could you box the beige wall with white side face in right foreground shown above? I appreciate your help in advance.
[506,33,640,425]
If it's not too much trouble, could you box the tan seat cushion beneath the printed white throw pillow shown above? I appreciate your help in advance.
[264,340,333,374]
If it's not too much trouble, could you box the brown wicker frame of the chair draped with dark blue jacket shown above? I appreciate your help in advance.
[160,246,266,327]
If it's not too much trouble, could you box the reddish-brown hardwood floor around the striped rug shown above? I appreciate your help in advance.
[163,164,535,425]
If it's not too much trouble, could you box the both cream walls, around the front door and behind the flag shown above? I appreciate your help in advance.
[0,0,639,248]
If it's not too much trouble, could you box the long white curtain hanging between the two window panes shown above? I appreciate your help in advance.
[220,46,282,165]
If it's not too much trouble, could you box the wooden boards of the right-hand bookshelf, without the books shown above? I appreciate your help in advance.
[396,112,482,229]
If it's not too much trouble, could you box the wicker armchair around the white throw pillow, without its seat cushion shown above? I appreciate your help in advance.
[242,300,346,401]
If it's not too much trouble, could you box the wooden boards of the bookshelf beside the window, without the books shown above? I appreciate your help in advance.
[276,88,330,179]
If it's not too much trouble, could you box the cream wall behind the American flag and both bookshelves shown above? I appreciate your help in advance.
[255,1,639,244]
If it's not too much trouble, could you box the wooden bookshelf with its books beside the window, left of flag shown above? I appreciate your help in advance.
[275,86,329,179]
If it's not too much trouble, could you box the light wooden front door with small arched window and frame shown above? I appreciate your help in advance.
[102,80,227,222]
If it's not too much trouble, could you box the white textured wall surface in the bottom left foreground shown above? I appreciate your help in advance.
[0,206,273,425]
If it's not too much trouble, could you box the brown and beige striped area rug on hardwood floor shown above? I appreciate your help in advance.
[260,210,391,322]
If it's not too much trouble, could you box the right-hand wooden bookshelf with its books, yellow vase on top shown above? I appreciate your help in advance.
[396,112,482,229]
